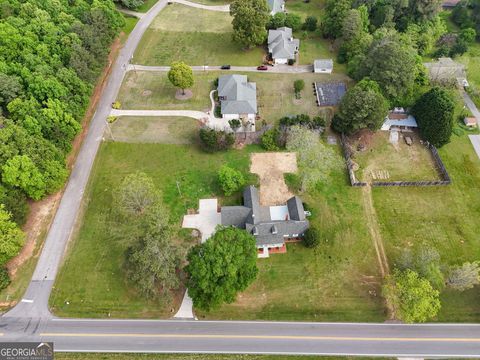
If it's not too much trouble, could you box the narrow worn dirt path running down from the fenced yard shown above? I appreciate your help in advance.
[362,185,390,277]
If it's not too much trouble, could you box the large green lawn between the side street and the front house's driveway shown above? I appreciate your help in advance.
[50,142,258,318]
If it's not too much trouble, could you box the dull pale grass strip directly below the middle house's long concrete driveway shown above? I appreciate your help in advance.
[106,117,199,144]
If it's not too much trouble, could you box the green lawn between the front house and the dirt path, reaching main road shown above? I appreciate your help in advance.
[197,166,385,321]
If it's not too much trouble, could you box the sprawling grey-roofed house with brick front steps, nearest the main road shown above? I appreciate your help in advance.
[220,186,309,257]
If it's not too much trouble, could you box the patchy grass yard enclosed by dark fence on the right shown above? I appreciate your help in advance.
[352,131,439,182]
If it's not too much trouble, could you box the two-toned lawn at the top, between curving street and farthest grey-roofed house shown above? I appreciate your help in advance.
[133,3,265,66]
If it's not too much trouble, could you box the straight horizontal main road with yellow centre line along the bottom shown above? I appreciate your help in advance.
[0,319,480,358]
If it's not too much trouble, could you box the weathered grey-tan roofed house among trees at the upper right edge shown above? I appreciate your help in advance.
[424,58,468,88]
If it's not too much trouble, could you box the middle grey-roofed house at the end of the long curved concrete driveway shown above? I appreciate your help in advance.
[218,75,257,124]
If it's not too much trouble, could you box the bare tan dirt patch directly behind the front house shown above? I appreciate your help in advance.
[250,153,298,205]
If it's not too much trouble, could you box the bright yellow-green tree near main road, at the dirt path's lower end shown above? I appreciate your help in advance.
[383,270,440,323]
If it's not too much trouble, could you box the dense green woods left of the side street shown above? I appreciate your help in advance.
[0,0,124,283]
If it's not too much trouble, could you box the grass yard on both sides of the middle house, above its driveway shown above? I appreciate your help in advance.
[118,71,347,122]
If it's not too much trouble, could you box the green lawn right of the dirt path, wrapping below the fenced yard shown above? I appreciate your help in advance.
[372,135,480,322]
